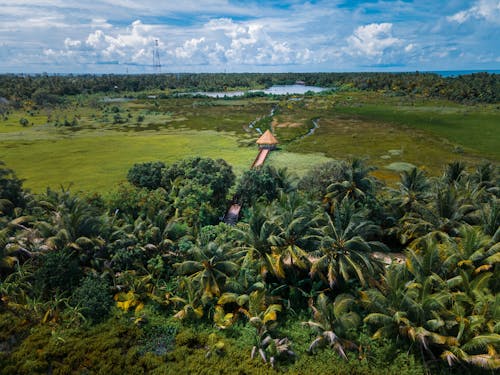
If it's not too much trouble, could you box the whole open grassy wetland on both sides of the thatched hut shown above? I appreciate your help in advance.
[0,92,500,192]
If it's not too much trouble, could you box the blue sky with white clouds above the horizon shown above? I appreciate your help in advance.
[0,0,500,74]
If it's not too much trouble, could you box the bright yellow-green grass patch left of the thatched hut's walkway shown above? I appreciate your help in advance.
[0,131,257,193]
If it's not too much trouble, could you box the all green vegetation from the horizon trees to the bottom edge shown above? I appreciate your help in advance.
[0,73,500,374]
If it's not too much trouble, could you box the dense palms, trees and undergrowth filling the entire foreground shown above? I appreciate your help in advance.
[0,158,500,374]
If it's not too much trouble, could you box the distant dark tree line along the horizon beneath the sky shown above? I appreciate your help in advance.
[0,72,500,105]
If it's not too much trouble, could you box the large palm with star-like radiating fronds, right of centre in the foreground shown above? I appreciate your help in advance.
[310,198,388,288]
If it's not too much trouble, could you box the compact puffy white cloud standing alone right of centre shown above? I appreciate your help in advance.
[347,23,401,57]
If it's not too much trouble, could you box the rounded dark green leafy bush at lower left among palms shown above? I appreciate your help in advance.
[71,276,114,323]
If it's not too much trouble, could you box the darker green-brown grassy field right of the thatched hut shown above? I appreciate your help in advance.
[274,93,500,181]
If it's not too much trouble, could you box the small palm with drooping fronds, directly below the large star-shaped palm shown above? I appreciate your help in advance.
[303,293,361,360]
